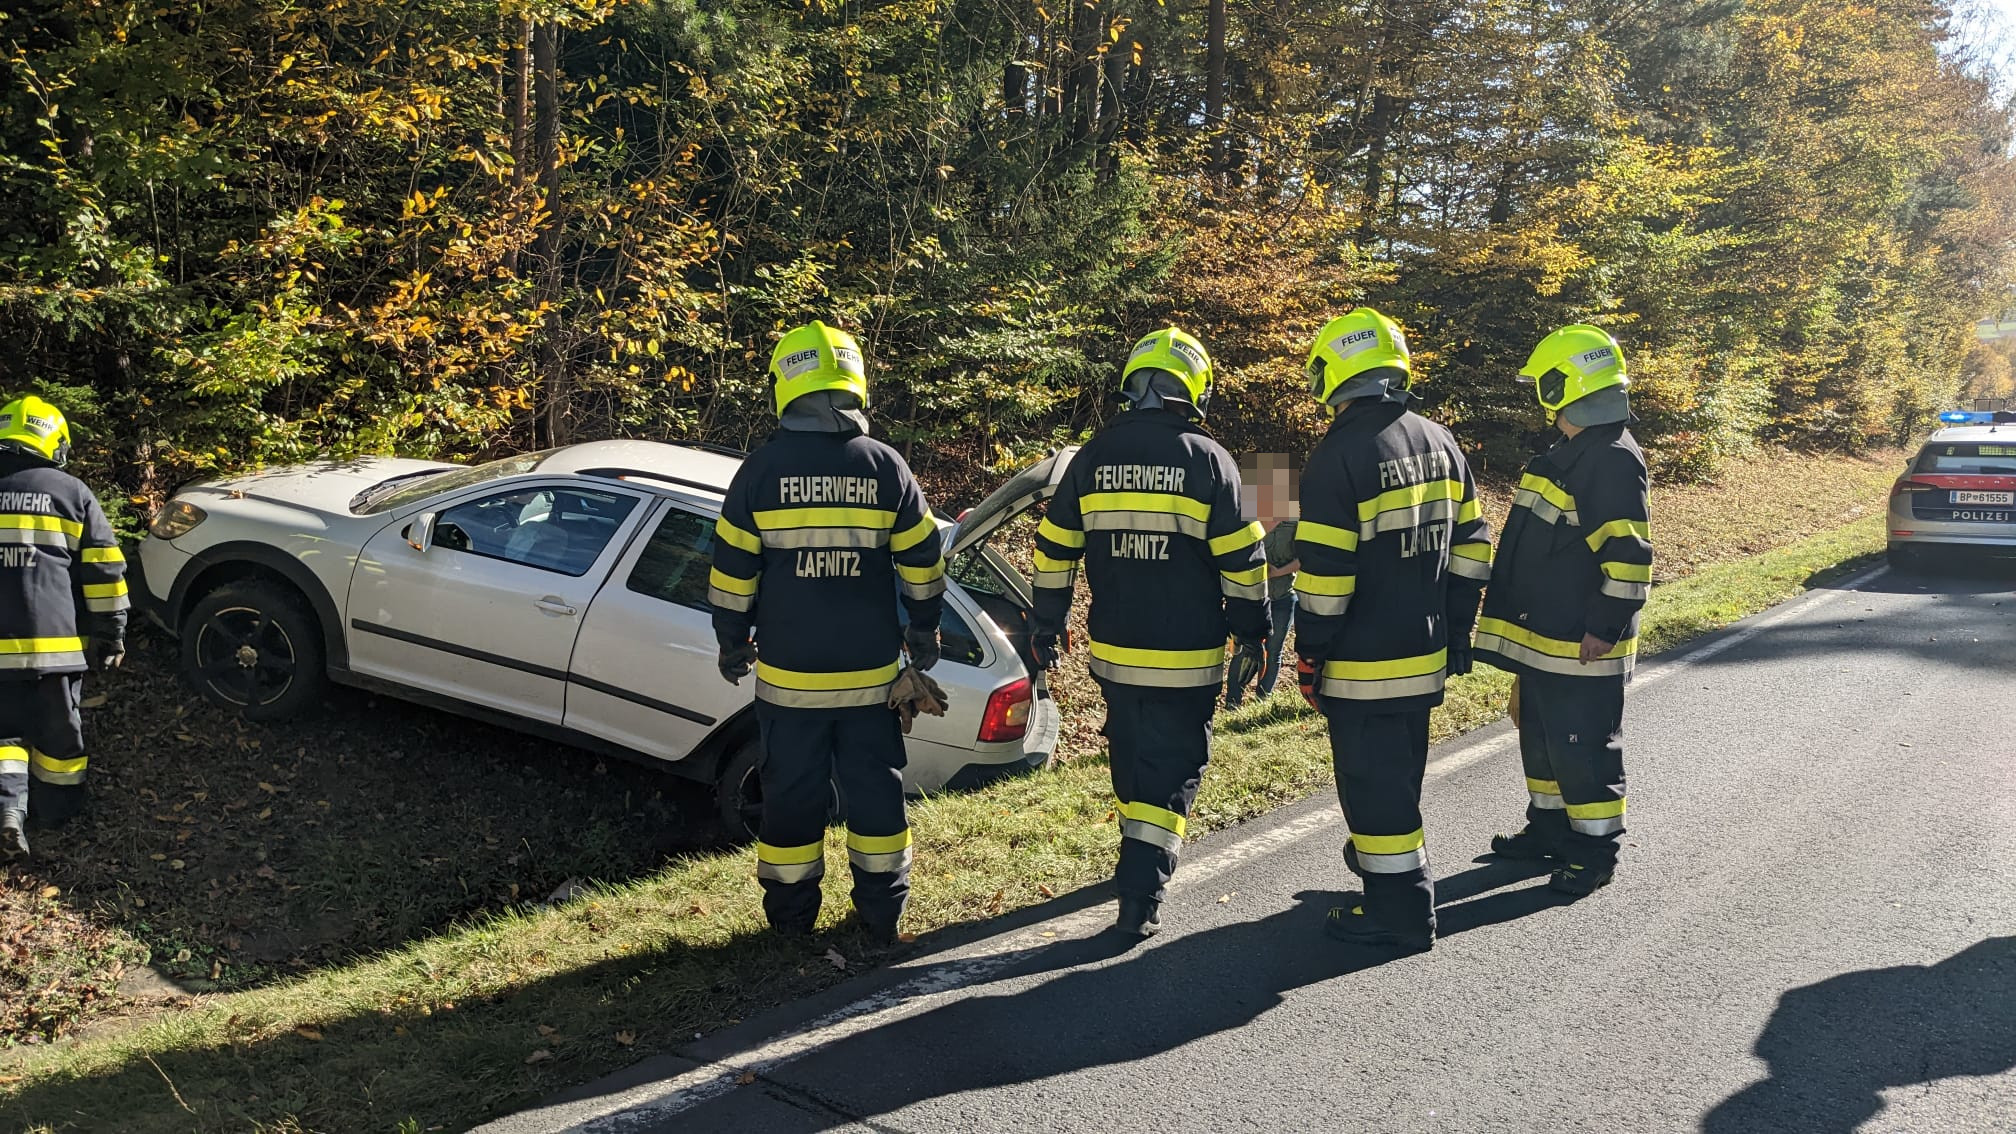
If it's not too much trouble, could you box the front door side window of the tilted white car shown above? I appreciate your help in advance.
[433,488,637,577]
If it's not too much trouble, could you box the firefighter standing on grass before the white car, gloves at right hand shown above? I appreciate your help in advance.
[708,323,946,944]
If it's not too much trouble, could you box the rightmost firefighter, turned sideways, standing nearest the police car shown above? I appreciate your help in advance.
[1478,325,1651,896]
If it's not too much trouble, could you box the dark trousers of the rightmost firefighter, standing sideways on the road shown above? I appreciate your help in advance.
[1518,674,1625,866]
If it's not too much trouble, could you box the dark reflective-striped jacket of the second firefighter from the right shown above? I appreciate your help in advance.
[1294,400,1492,712]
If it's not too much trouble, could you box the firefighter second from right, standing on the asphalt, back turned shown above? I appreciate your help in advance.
[1294,307,1492,950]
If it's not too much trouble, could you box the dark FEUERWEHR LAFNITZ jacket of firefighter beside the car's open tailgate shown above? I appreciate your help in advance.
[1034,410,1268,688]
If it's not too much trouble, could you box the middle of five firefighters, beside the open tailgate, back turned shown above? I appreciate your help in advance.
[1032,327,1268,936]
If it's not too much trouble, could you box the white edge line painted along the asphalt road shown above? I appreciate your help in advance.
[478,565,1885,1134]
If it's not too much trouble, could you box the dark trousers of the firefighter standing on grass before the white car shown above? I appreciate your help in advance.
[756,700,909,930]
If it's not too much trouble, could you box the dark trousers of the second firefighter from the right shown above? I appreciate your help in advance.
[1320,696,1435,932]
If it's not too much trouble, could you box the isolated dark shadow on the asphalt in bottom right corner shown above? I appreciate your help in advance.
[1702,936,2016,1134]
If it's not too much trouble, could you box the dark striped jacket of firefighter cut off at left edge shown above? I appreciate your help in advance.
[0,452,129,680]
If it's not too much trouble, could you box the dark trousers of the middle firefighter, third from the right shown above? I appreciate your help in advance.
[1099,680,1218,902]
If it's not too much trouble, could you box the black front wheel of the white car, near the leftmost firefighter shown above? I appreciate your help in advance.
[181,581,327,720]
